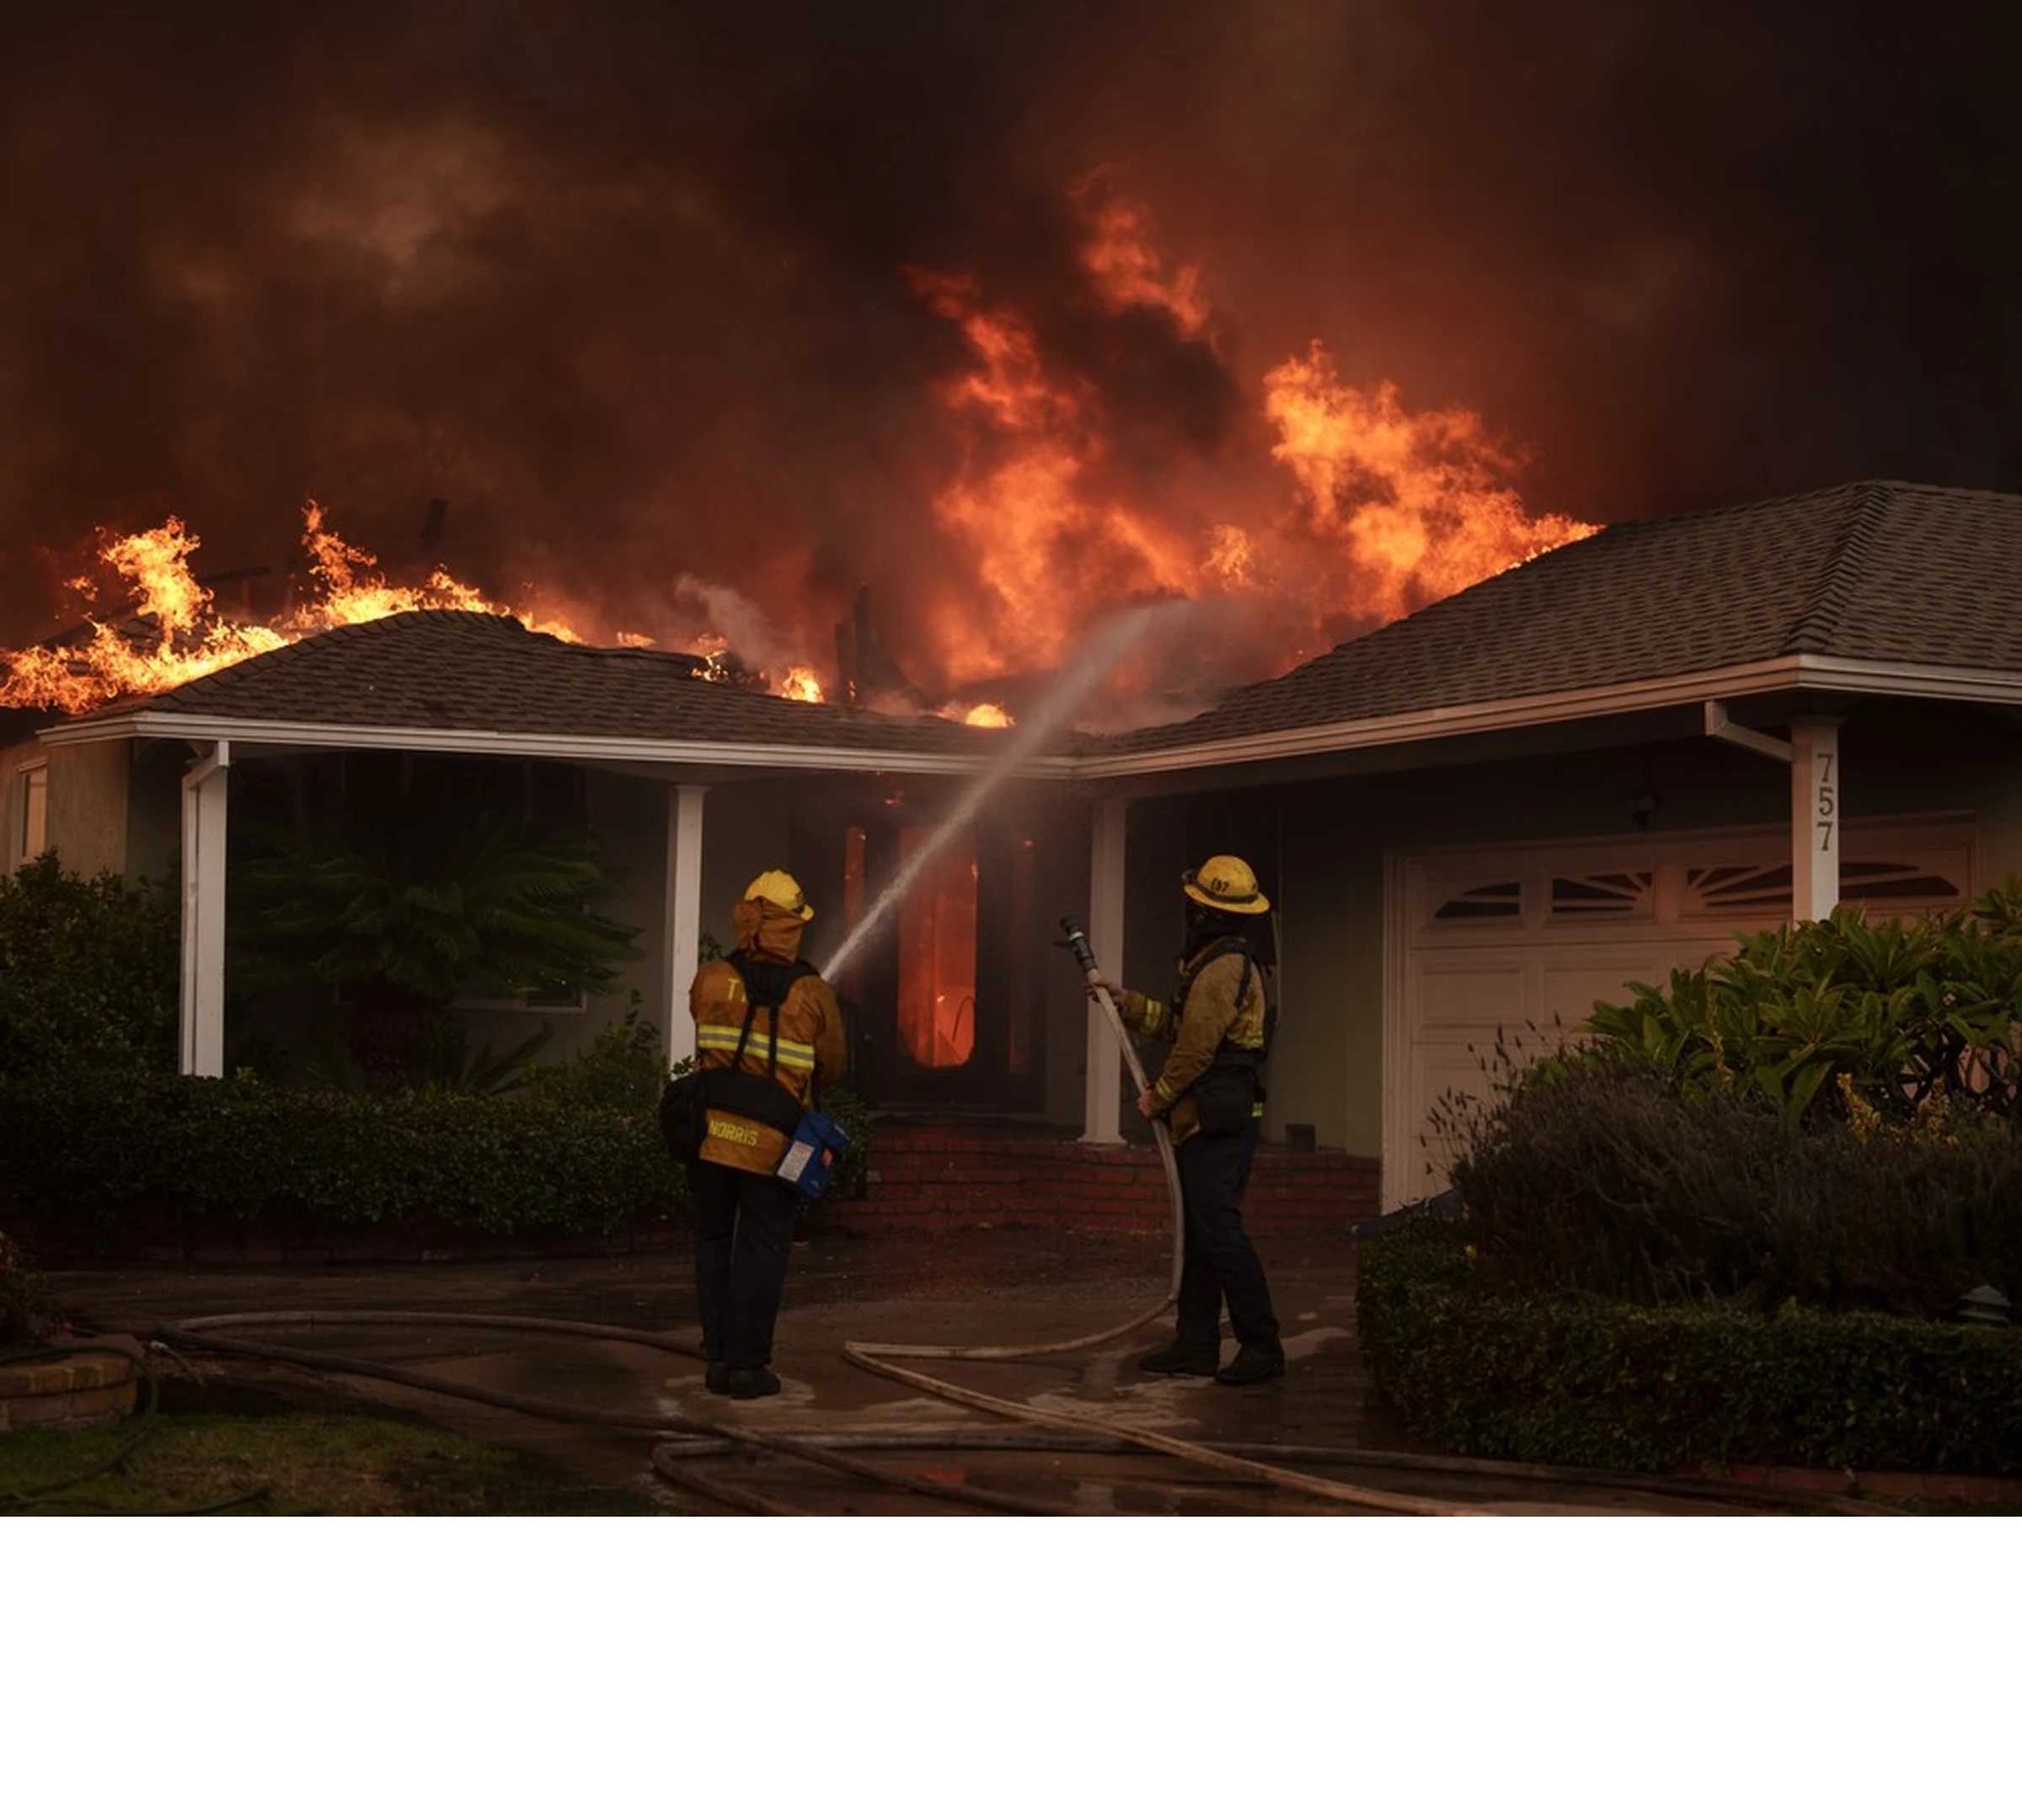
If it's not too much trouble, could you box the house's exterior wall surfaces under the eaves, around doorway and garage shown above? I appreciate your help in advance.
[27,702,2022,1157]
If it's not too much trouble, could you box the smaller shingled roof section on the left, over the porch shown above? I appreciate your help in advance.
[95,608,992,758]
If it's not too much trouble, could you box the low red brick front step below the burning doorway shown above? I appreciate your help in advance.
[835,1121,1379,1234]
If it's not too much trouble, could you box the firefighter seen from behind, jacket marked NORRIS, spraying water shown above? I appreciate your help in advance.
[687,871,843,1397]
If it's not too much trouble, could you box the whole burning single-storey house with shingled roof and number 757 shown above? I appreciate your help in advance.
[0,484,2022,1202]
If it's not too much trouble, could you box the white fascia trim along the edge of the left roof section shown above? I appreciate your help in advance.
[40,709,1073,777]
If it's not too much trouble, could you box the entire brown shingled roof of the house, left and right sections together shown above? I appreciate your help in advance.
[47,481,2022,774]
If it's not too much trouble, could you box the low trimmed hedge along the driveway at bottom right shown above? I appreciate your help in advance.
[1356,1213,2022,1472]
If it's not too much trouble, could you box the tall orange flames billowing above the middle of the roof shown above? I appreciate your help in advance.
[910,180,1597,683]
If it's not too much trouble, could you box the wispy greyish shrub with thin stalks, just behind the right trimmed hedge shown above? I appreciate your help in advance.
[1452,1052,2022,1319]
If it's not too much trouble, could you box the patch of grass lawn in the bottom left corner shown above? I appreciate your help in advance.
[0,1410,666,1517]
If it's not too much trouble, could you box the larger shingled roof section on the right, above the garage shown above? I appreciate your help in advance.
[1100,481,2022,754]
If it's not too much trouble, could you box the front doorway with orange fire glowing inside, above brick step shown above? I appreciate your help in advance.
[805,790,1047,1116]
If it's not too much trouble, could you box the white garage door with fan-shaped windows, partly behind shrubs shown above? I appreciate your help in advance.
[1383,823,1973,1205]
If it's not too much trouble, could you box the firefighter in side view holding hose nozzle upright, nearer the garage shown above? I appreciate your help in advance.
[1088,854,1284,1384]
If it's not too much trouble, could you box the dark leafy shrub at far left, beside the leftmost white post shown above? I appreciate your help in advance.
[0,851,178,1078]
